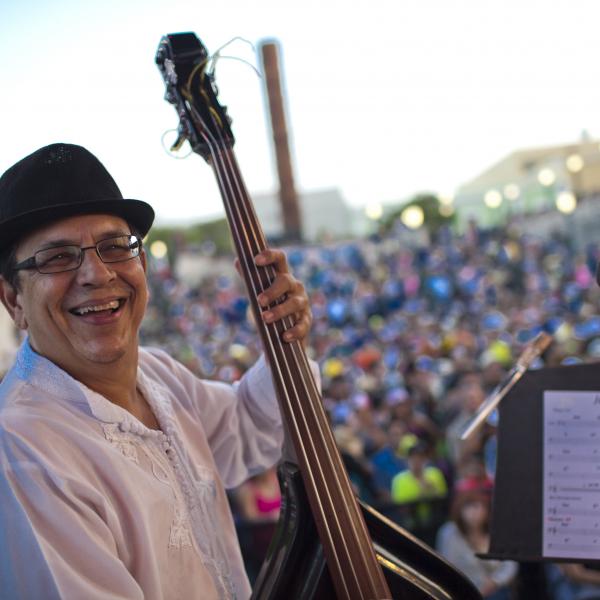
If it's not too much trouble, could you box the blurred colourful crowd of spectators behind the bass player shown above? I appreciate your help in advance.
[142,224,600,600]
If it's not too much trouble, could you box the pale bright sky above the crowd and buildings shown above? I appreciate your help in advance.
[0,0,600,224]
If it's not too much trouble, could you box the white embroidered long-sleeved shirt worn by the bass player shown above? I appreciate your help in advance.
[0,341,290,600]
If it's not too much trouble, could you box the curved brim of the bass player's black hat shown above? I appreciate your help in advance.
[0,199,154,252]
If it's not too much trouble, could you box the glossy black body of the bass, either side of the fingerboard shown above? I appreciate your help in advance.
[252,462,481,600]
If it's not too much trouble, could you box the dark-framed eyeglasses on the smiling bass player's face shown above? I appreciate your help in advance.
[13,235,142,274]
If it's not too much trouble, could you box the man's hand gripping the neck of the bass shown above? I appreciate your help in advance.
[254,249,312,343]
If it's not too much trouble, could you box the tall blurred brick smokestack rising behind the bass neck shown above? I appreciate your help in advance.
[261,42,302,242]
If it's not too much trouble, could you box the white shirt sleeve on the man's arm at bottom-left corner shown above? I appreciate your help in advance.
[0,431,143,600]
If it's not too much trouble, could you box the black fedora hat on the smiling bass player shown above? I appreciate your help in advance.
[0,143,154,251]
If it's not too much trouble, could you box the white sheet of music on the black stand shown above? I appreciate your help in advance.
[542,391,600,559]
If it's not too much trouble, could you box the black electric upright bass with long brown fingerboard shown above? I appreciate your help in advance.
[156,33,481,600]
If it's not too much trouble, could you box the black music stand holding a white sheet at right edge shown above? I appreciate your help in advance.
[480,363,600,563]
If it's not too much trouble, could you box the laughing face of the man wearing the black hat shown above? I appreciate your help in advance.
[4,215,148,374]
